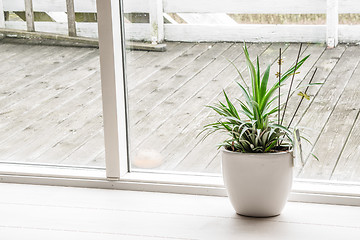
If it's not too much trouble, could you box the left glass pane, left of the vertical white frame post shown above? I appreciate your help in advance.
[0,0,105,167]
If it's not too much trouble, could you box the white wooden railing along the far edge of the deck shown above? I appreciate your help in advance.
[0,0,360,46]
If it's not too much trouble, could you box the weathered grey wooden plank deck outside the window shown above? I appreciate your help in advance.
[0,40,360,181]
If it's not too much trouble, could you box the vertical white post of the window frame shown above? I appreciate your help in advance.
[97,0,128,179]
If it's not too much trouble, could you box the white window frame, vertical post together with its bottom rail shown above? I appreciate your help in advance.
[0,0,360,206]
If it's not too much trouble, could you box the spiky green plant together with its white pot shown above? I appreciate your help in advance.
[201,44,316,217]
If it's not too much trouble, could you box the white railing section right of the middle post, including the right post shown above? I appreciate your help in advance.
[164,0,360,46]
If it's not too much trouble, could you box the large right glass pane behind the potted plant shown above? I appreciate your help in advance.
[124,1,360,186]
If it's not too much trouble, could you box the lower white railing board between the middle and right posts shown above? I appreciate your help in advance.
[164,24,326,42]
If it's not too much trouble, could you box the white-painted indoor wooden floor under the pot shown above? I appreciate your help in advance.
[0,183,360,240]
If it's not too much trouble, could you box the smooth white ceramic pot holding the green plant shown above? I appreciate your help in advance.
[222,148,293,217]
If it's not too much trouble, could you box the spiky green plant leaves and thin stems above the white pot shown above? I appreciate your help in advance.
[201,44,316,153]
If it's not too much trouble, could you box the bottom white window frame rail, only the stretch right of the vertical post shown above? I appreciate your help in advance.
[118,172,360,206]
